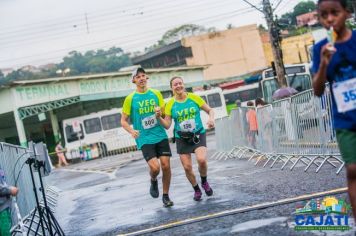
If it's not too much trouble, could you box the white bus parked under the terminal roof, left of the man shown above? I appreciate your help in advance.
[63,108,173,159]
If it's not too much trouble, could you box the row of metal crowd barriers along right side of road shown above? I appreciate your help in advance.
[214,89,344,173]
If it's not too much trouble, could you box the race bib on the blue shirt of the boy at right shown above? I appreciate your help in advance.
[333,78,356,112]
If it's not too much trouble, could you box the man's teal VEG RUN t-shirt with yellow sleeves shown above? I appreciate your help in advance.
[122,89,168,149]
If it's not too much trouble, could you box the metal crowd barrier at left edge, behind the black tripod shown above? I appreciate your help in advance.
[0,143,58,235]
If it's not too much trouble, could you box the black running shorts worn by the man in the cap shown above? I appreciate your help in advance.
[141,139,172,162]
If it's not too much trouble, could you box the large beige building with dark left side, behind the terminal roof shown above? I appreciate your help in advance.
[133,25,266,80]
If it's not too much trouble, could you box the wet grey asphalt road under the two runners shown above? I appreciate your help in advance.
[49,135,350,235]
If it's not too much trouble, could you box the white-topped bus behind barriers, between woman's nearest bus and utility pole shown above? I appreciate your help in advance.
[223,83,261,113]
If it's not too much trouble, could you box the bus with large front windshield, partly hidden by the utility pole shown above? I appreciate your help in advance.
[261,63,312,103]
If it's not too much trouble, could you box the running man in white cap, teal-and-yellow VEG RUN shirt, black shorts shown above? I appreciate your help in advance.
[121,67,173,207]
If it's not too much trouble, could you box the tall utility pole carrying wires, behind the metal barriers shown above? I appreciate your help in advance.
[262,0,287,87]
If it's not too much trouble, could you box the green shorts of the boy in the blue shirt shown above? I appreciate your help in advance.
[336,129,356,164]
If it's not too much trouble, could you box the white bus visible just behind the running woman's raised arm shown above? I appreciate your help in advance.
[194,88,227,129]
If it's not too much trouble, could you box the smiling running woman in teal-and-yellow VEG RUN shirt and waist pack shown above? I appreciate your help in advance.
[157,77,214,201]
